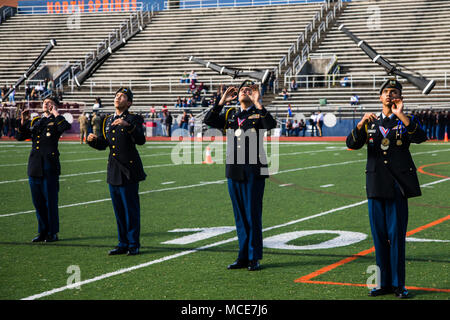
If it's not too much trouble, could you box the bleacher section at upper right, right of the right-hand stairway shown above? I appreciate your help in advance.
[272,0,450,117]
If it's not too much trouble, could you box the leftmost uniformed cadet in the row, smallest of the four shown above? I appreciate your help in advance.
[16,97,71,242]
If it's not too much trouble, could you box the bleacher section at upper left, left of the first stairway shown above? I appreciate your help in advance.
[0,12,139,81]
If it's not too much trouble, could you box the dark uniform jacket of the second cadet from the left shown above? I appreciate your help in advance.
[88,111,146,186]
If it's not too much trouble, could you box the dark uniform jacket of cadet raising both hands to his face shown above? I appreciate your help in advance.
[204,101,277,181]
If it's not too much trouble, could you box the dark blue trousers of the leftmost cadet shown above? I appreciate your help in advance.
[28,171,59,235]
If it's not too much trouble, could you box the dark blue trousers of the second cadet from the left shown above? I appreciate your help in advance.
[109,183,141,248]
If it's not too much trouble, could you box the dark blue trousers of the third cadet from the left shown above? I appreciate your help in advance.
[228,174,265,260]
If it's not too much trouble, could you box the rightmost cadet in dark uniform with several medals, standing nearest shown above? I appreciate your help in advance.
[347,79,427,298]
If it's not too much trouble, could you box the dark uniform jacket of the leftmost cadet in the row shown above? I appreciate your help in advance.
[17,115,71,178]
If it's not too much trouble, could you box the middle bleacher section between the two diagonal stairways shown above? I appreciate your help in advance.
[60,3,322,110]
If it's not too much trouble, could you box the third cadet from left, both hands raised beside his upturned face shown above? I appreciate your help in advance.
[204,80,276,271]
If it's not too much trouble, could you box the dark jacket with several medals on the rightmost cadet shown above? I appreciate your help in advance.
[346,115,427,199]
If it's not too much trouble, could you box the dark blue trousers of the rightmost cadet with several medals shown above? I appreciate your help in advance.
[369,186,408,288]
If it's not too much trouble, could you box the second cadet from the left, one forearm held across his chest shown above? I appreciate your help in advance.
[88,88,146,255]
